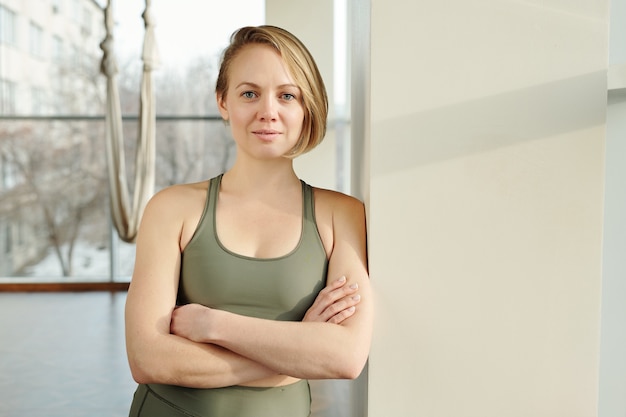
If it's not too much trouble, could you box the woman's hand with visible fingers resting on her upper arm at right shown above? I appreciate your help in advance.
[302,277,361,324]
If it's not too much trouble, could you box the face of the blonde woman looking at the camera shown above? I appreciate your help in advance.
[217,45,304,159]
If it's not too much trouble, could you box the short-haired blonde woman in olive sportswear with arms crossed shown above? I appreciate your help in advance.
[126,26,372,417]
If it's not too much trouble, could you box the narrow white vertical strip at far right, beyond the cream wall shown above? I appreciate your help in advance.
[598,0,626,417]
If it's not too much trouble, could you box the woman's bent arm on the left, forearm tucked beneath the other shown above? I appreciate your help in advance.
[126,186,276,388]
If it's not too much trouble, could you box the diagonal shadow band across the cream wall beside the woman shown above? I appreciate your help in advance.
[372,71,607,174]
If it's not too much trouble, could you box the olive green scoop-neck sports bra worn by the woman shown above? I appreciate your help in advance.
[178,175,328,321]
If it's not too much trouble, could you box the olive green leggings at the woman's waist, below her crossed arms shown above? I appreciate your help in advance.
[129,380,311,417]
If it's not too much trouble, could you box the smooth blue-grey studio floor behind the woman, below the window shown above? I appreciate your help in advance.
[0,292,355,417]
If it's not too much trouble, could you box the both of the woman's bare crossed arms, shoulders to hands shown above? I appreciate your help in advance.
[126,185,373,388]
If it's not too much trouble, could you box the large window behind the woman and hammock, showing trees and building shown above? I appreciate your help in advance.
[0,0,264,282]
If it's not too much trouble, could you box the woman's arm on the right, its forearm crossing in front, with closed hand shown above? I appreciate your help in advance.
[172,193,373,379]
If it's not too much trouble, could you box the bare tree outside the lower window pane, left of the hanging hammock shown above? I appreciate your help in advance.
[0,124,106,277]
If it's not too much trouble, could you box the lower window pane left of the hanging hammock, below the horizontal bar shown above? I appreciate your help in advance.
[0,121,109,281]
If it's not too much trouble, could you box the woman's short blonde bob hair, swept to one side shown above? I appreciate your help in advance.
[215,25,328,158]
